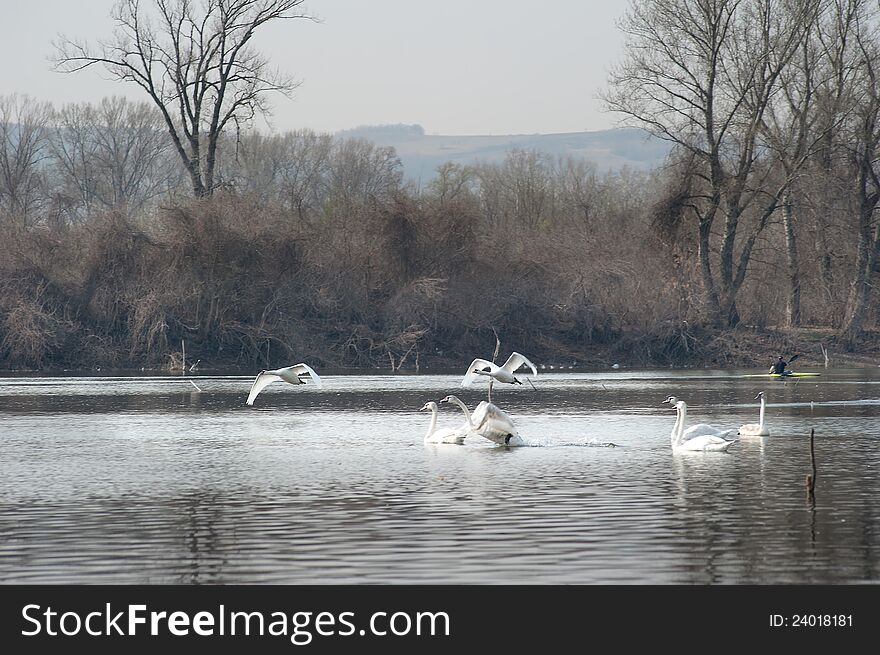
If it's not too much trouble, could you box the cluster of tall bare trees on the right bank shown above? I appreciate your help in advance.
[604,0,880,348]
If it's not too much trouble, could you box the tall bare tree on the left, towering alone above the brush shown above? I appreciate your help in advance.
[56,0,309,196]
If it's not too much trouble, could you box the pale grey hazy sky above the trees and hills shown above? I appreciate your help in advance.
[0,0,626,135]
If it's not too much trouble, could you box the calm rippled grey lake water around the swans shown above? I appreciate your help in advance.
[0,368,880,585]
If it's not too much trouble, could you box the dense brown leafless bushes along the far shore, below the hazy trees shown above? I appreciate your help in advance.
[0,192,880,371]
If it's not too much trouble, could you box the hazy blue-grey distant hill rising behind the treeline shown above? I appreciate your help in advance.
[338,125,669,183]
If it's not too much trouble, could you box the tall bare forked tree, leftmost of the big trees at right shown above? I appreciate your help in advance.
[604,0,819,325]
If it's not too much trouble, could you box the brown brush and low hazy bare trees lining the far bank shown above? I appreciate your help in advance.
[0,89,878,370]
